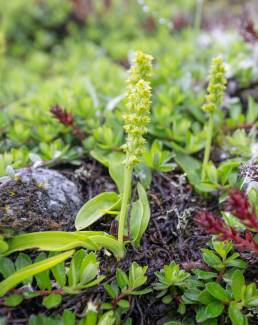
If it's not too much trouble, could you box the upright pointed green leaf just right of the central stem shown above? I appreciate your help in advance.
[130,183,150,247]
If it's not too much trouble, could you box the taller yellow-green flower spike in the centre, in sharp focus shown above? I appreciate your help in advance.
[123,51,152,167]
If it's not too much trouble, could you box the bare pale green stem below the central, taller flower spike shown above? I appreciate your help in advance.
[118,167,133,244]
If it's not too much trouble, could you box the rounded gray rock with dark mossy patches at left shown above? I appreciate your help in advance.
[0,168,83,233]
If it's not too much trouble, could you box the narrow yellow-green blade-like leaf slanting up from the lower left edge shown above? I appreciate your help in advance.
[0,250,74,296]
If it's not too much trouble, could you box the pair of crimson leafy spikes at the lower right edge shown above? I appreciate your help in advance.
[195,190,258,253]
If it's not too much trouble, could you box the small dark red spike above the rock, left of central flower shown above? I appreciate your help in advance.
[50,105,85,140]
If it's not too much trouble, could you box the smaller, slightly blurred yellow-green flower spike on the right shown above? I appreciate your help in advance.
[202,57,227,113]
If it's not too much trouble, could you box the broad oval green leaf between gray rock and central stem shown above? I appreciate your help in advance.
[75,192,121,230]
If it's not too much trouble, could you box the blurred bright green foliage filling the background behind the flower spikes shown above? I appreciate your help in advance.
[0,0,258,182]
